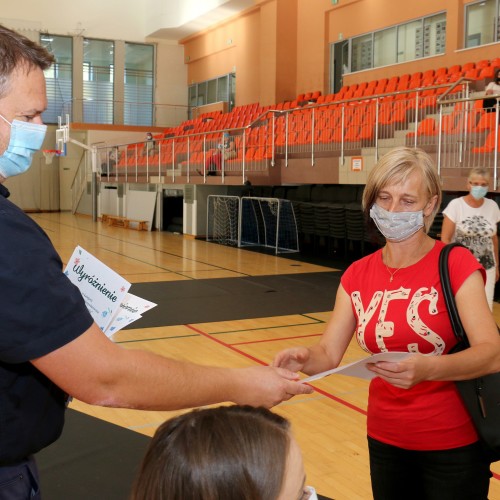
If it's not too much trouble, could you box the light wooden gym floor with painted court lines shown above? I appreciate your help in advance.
[31,213,500,500]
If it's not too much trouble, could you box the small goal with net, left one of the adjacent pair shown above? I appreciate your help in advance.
[207,195,240,246]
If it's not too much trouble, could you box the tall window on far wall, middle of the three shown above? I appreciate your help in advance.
[83,38,114,124]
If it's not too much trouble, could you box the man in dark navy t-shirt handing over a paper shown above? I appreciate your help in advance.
[0,26,312,500]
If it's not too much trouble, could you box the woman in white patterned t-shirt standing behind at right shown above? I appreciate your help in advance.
[441,167,500,311]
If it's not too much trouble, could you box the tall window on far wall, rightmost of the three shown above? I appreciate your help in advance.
[124,43,154,125]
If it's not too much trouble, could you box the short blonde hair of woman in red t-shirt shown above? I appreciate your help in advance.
[363,147,442,232]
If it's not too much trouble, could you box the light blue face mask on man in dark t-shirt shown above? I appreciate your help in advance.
[0,115,47,179]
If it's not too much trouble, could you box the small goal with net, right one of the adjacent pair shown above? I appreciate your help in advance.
[239,196,299,253]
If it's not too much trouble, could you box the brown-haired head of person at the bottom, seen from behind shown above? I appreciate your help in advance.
[131,406,317,500]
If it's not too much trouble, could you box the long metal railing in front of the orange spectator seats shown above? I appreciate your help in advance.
[87,80,499,189]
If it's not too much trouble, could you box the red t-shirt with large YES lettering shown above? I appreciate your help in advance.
[341,241,484,450]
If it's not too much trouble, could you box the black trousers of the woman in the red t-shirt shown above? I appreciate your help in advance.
[368,437,491,500]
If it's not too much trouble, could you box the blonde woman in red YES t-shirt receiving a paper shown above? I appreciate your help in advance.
[273,147,500,500]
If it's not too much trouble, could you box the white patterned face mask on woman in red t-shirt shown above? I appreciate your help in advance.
[370,203,424,242]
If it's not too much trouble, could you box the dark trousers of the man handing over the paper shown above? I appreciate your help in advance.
[0,457,42,500]
